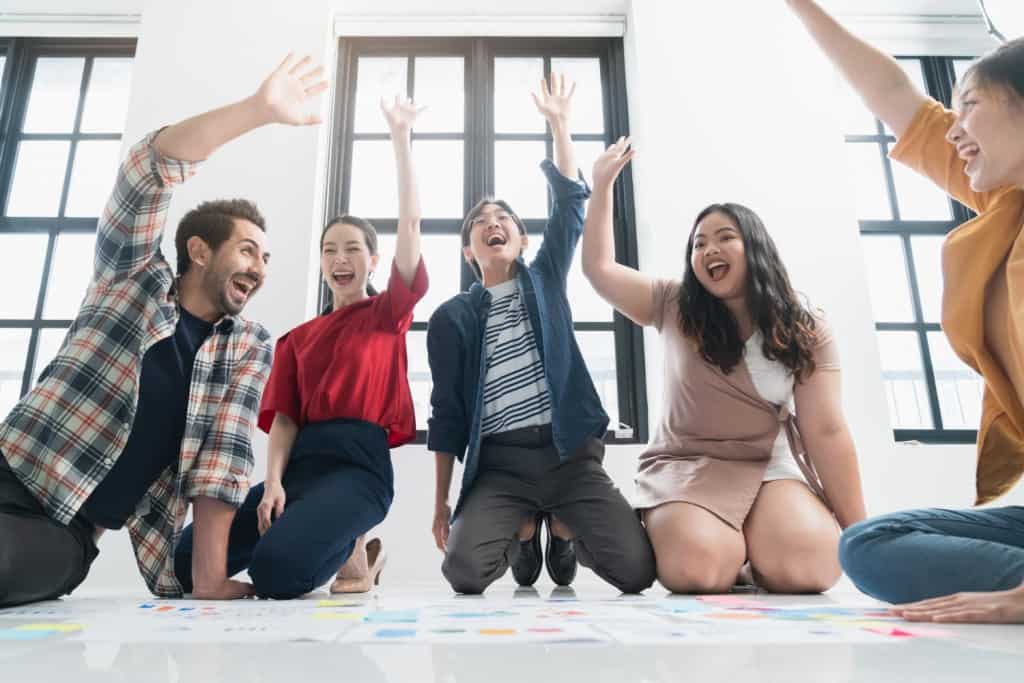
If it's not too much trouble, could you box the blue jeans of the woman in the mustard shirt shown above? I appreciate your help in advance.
[839,507,1024,603]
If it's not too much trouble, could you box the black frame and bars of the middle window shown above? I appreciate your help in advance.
[327,37,648,444]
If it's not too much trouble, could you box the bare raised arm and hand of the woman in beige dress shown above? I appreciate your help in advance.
[583,137,654,325]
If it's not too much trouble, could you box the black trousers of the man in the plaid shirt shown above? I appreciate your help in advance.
[0,454,99,607]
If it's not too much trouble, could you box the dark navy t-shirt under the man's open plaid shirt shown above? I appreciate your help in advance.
[81,308,213,528]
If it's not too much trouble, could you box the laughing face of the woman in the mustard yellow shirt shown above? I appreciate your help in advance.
[946,76,1024,193]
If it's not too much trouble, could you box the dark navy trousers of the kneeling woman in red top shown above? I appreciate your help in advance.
[174,420,393,600]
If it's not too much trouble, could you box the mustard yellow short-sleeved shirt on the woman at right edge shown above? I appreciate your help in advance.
[890,100,1024,504]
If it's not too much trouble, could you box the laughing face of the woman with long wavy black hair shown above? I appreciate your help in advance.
[690,211,746,300]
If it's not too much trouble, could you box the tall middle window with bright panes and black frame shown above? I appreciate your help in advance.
[324,39,647,441]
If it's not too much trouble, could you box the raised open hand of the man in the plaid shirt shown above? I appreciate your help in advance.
[253,53,327,126]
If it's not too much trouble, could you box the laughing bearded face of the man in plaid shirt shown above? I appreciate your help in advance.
[194,218,270,315]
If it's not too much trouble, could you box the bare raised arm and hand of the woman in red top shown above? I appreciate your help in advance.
[381,97,426,286]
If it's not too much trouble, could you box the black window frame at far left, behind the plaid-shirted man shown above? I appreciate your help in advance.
[0,38,136,396]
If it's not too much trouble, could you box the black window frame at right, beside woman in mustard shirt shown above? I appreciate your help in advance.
[846,54,978,443]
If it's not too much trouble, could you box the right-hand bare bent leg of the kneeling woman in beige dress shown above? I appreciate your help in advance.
[743,479,842,593]
